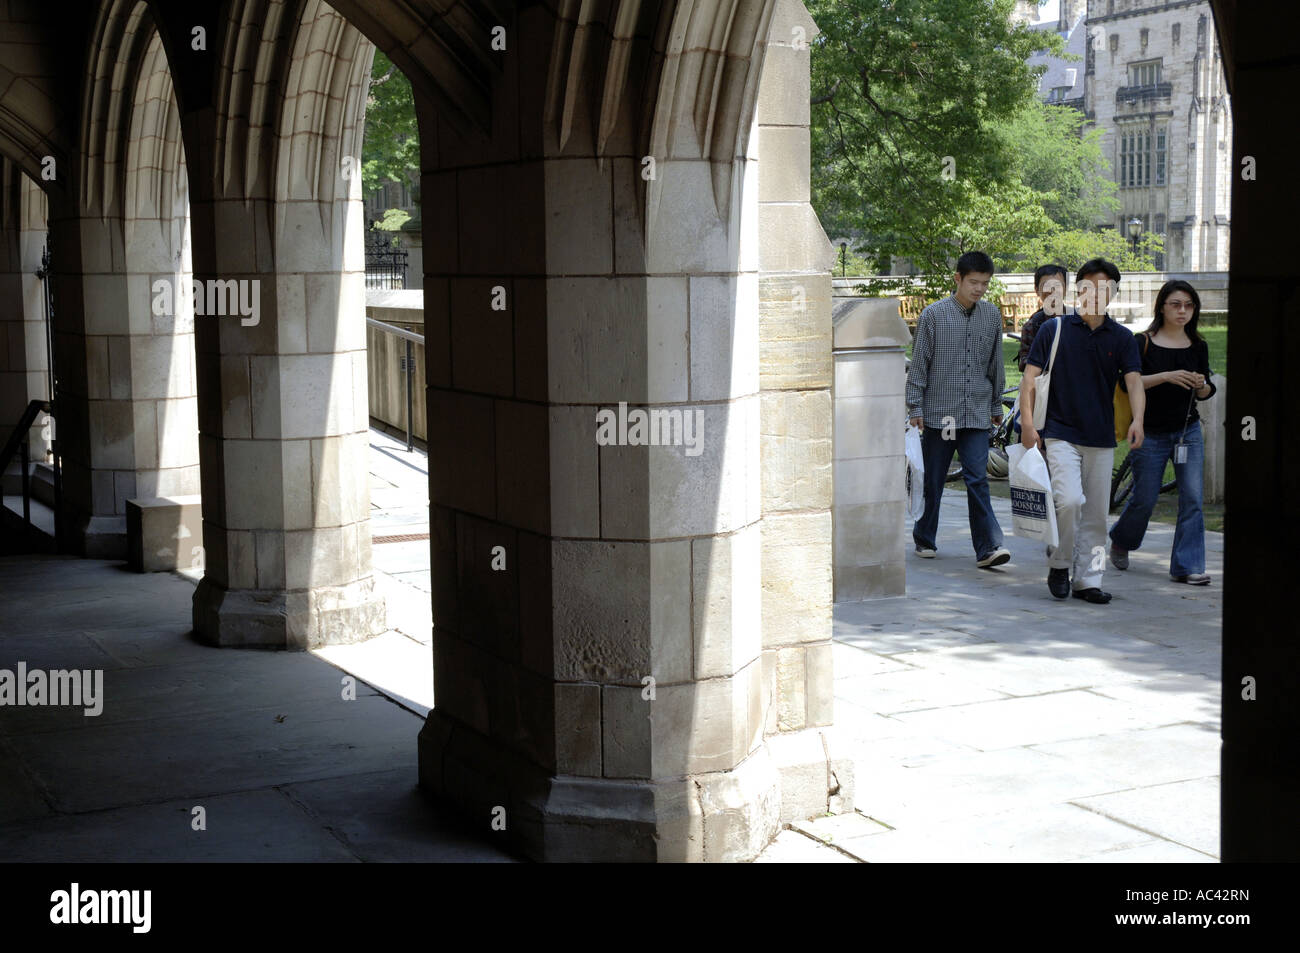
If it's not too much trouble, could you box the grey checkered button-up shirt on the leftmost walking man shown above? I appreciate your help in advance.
[906,295,1005,430]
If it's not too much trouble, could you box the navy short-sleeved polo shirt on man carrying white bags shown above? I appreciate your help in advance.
[1027,315,1141,447]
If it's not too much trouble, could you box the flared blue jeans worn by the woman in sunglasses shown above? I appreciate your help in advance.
[1110,420,1205,576]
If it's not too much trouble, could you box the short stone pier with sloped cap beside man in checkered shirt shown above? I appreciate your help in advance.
[835,298,911,602]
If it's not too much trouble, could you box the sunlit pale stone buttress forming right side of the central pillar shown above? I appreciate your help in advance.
[754,0,853,822]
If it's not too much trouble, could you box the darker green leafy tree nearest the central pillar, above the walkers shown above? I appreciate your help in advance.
[809,0,1063,293]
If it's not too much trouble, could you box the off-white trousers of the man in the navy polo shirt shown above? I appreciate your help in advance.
[1043,438,1115,590]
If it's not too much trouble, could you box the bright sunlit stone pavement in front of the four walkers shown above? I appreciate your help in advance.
[833,490,1223,863]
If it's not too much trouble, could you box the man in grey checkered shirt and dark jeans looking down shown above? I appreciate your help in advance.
[907,251,1011,568]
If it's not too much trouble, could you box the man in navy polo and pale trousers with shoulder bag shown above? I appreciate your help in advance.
[1021,259,1147,605]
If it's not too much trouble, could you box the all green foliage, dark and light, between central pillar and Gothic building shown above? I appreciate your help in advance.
[807,0,1158,294]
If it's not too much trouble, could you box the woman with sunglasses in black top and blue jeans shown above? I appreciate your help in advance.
[1110,281,1216,585]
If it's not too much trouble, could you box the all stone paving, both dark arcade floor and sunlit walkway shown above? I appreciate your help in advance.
[0,432,1222,863]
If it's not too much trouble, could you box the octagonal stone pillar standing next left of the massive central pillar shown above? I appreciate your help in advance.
[187,1,385,649]
